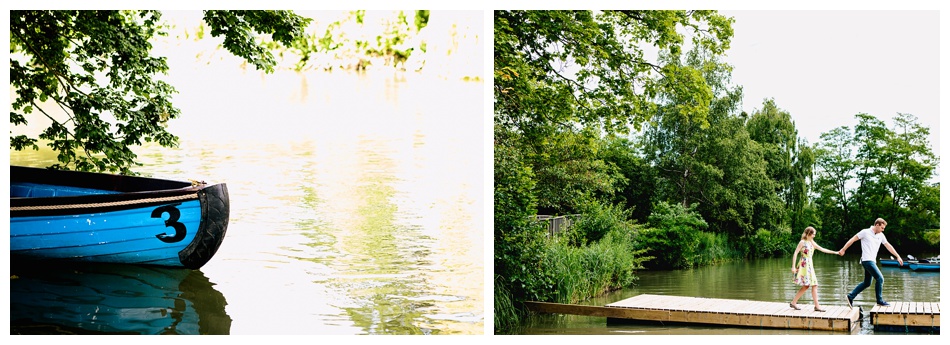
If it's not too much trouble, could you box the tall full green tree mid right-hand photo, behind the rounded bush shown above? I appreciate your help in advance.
[644,48,787,239]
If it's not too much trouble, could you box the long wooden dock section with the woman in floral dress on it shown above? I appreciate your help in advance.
[525,294,861,332]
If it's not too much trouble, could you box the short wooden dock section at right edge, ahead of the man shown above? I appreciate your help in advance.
[871,302,940,332]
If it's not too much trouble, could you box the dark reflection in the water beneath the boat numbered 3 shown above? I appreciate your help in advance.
[10,264,231,334]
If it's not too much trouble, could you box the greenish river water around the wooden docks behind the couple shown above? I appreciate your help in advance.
[519,254,940,335]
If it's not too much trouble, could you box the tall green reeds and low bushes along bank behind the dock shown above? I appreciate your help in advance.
[494,200,768,334]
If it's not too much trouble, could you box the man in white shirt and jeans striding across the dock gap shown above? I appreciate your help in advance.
[838,218,904,309]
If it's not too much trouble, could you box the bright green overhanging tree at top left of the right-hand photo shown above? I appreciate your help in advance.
[494,11,732,218]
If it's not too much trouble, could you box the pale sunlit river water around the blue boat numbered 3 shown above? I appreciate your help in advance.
[10,73,487,335]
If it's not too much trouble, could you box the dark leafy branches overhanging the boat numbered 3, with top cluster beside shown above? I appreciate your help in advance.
[10,11,310,174]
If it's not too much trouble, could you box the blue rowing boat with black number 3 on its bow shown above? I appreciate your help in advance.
[10,166,230,269]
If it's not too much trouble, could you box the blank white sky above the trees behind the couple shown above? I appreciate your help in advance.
[720,10,940,177]
